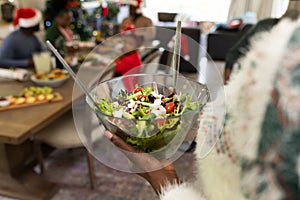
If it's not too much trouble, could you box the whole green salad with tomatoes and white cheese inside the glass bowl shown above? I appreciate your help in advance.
[98,83,201,152]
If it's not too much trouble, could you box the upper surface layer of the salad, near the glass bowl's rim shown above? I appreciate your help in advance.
[98,84,201,120]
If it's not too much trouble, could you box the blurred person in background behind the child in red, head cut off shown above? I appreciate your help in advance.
[120,0,155,43]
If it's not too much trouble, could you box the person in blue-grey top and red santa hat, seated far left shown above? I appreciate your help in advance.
[0,8,43,67]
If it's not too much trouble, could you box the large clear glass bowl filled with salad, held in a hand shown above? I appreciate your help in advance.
[87,74,209,159]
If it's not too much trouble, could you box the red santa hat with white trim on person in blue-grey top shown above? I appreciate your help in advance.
[13,8,42,28]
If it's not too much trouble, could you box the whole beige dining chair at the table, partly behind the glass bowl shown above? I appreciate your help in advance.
[34,59,120,189]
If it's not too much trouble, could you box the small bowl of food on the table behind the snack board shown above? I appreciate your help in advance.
[30,69,70,87]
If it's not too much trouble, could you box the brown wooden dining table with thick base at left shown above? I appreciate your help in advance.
[0,68,102,200]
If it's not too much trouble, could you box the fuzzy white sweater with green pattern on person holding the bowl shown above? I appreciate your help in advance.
[160,18,300,200]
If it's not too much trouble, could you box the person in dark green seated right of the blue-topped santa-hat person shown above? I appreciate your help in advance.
[45,9,73,54]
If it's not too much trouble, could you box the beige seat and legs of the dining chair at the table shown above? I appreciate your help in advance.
[34,110,96,189]
